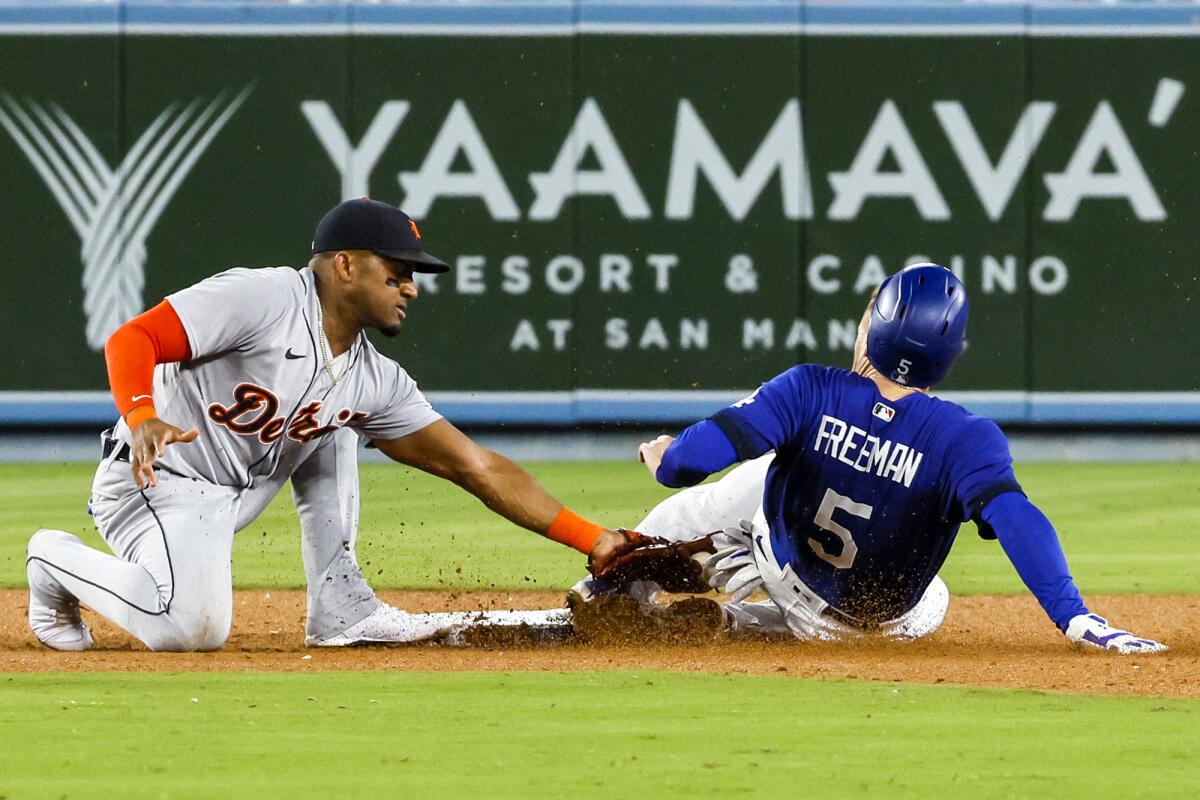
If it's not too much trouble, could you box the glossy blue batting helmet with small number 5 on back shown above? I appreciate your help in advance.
[866,264,968,389]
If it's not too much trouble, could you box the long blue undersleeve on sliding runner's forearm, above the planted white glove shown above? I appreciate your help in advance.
[982,492,1087,631]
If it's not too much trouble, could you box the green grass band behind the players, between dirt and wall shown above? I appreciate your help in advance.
[0,462,1200,594]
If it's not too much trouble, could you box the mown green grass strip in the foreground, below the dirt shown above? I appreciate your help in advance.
[0,672,1200,800]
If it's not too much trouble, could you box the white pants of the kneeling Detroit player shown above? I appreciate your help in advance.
[29,429,380,651]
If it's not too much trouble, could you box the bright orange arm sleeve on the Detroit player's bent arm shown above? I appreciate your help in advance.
[104,300,192,431]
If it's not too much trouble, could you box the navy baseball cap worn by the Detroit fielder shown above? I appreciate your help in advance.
[312,198,450,272]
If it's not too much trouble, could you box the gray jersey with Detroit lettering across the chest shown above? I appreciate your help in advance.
[118,266,442,489]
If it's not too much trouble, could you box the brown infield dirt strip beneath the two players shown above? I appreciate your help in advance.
[0,589,1200,698]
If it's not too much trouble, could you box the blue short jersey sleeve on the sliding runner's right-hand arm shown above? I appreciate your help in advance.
[947,416,1021,539]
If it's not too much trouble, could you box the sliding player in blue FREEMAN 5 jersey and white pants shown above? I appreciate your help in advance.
[595,264,1166,652]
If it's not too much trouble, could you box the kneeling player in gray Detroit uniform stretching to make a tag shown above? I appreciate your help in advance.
[26,198,624,651]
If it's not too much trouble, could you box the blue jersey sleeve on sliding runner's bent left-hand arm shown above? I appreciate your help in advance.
[712,365,818,461]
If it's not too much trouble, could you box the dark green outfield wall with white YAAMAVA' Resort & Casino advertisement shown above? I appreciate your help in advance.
[0,4,1200,424]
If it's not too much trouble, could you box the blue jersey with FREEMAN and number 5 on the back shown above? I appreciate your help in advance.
[712,365,1020,622]
